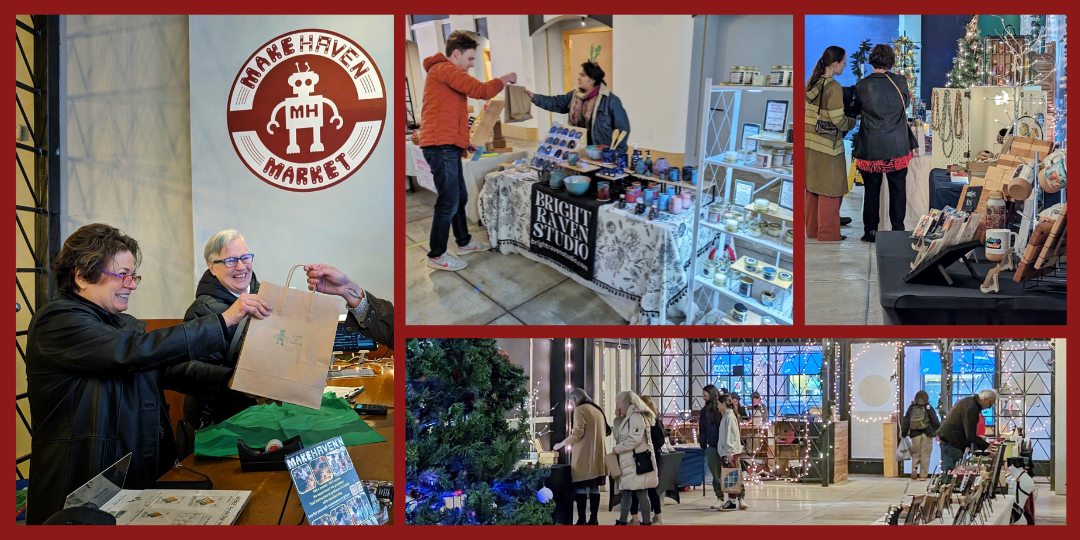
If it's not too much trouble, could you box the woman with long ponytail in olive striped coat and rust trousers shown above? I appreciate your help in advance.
[804,45,855,242]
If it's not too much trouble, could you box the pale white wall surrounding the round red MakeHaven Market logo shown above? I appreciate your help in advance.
[181,15,401,306]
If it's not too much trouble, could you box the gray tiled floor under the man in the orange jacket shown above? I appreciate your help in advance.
[405,139,626,324]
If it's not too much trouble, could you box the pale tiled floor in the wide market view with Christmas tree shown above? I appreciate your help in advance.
[599,476,1065,525]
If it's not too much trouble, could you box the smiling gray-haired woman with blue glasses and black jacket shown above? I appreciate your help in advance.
[178,229,259,444]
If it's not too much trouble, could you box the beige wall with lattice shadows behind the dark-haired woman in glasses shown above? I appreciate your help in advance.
[60,15,196,319]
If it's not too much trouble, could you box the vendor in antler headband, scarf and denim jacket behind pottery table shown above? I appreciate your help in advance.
[525,62,630,152]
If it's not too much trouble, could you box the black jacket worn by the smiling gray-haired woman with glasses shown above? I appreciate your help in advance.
[184,270,259,429]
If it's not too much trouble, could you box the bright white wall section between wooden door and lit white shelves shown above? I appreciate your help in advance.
[611,15,693,153]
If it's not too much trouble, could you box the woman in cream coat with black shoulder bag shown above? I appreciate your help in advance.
[611,391,659,525]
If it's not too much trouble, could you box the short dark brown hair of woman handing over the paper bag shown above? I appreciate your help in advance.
[53,224,140,294]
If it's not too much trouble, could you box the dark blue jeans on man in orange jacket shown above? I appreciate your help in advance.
[422,145,472,259]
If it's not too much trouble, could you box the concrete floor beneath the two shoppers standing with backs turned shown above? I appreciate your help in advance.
[804,186,885,325]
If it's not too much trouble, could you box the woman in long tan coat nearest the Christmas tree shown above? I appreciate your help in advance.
[552,388,611,525]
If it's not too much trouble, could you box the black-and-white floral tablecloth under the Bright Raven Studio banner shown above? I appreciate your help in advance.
[480,166,719,324]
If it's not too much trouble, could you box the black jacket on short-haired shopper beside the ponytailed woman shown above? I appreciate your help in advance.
[851,73,913,160]
